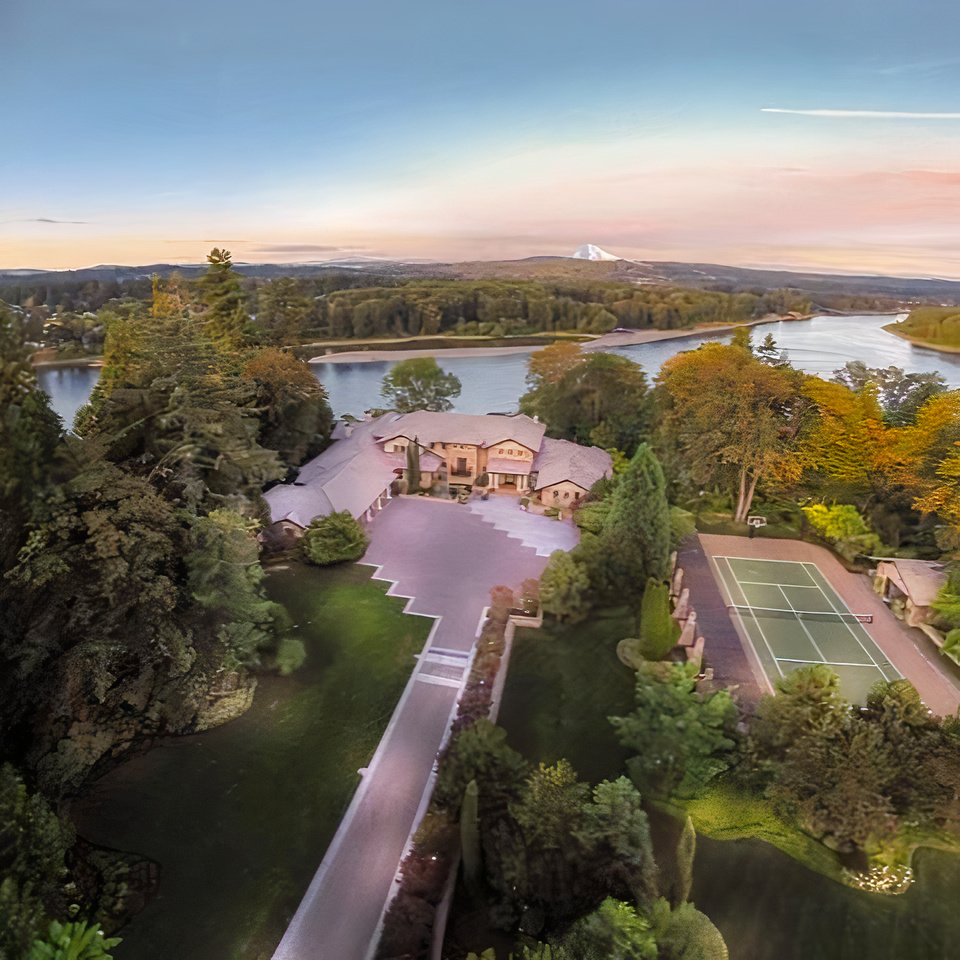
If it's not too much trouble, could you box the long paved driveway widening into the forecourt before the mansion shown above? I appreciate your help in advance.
[274,497,575,960]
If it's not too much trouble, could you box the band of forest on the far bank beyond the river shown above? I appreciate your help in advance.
[7,273,811,359]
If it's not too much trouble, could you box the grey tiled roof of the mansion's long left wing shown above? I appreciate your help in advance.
[264,414,402,527]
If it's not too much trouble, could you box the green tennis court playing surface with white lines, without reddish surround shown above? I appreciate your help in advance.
[714,557,900,703]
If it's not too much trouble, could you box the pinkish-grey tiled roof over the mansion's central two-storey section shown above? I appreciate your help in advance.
[375,410,546,451]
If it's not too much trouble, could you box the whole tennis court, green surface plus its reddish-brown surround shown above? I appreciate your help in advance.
[699,534,960,715]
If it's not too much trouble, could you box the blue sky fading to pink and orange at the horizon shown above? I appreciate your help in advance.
[0,0,960,279]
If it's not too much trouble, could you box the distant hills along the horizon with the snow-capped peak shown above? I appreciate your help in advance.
[0,255,960,303]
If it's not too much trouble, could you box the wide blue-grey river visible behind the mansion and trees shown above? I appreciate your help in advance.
[38,316,960,426]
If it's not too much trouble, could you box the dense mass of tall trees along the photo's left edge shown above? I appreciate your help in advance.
[0,251,331,960]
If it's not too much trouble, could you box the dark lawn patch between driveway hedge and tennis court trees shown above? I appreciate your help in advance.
[498,607,636,783]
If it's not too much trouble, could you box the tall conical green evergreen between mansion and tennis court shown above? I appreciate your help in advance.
[603,443,670,595]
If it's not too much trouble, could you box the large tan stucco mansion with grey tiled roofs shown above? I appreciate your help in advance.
[264,411,612,529]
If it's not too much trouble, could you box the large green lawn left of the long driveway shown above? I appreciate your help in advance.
[78,564,430,960]
